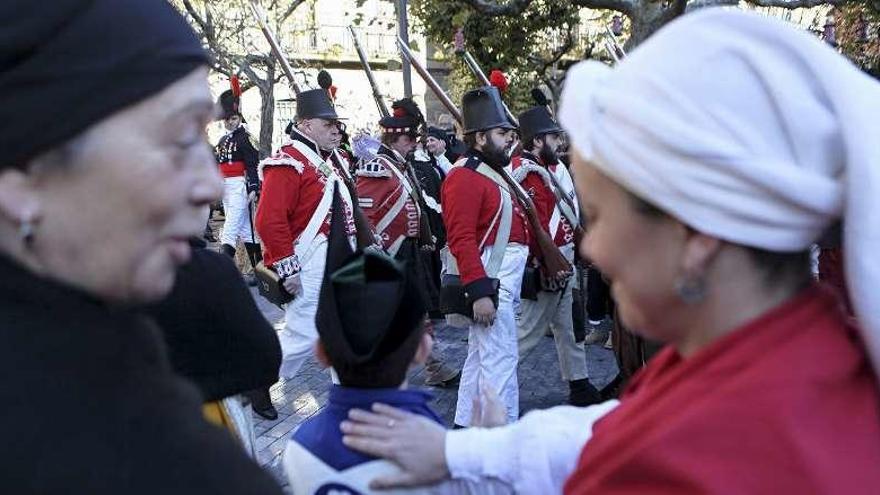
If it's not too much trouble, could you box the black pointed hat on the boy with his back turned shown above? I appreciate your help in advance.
[315,185,426,388]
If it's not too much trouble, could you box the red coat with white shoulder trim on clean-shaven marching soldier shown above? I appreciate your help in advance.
[255,130,355,276]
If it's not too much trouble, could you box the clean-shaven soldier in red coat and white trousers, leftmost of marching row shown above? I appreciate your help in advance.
[256,89,355,392]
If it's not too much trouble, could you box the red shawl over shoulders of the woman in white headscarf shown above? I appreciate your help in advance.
[565,287,880,495]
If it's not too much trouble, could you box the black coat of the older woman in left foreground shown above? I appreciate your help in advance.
[0,258,281,495]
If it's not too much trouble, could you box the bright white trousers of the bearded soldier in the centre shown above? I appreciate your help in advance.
[455,244,529,426]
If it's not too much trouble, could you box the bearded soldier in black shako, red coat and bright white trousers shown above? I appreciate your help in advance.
[443,86,529,426]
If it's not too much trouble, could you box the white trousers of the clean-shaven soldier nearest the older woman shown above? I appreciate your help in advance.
[278,234,327,379]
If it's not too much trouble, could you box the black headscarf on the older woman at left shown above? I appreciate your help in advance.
[0,0,208,169]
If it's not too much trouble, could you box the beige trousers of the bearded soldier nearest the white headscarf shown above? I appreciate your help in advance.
[518,244,587,381]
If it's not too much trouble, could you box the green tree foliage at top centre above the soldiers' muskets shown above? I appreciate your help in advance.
[410,0,584,109]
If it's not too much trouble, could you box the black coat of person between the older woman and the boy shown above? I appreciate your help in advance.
[147,244,281,401]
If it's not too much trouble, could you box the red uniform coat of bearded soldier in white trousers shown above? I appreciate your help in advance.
[442,150,529,300]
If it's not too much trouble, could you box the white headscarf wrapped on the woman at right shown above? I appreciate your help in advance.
[560,8,880,370]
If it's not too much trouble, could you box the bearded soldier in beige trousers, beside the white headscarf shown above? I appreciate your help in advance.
[511,106,598,406]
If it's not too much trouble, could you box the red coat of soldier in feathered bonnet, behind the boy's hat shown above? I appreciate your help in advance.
[357,145,422,250]
